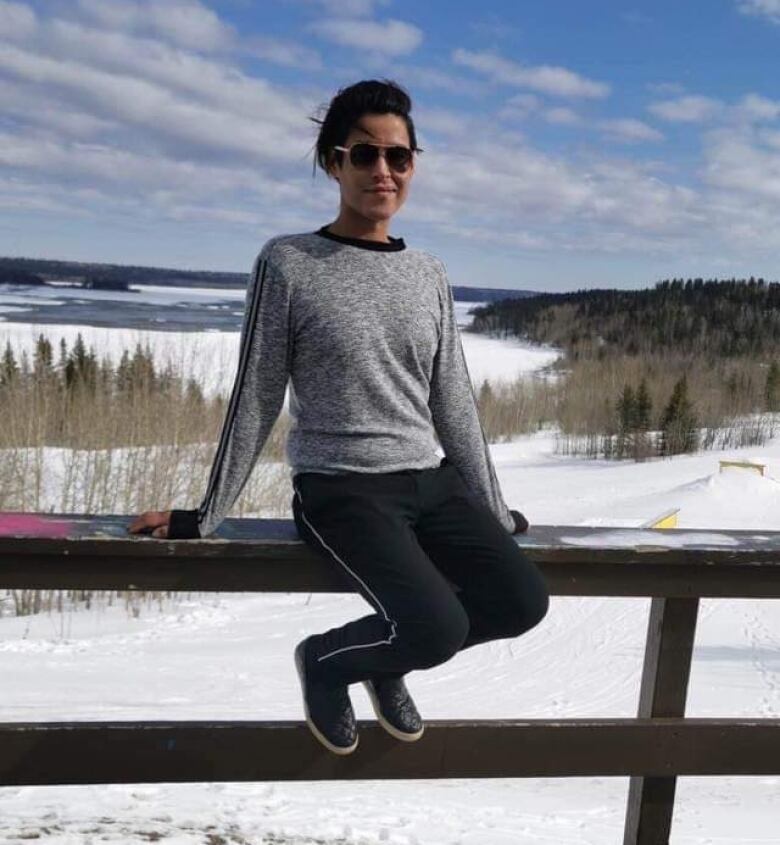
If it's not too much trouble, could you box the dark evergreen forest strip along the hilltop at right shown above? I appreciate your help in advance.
[474,277,780,360]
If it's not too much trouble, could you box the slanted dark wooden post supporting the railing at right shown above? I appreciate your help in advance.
[623,598,699,845]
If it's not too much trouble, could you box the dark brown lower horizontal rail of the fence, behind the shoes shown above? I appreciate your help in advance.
[0,719,780,786]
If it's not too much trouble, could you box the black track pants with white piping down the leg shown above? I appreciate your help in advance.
[293,458,549,684]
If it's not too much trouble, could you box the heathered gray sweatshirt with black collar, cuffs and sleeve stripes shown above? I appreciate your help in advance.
[168,227,515,538]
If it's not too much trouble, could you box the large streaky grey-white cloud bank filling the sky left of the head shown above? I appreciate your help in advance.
[0,2,326,241]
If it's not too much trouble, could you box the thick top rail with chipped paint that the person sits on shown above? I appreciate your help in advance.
[0,514,780,598]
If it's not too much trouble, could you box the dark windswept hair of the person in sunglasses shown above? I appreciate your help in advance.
[311,79,417,175]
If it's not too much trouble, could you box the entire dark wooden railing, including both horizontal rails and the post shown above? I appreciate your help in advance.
[0,515,780,845]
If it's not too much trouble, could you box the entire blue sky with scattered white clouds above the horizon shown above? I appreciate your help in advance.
[0,0,780,291]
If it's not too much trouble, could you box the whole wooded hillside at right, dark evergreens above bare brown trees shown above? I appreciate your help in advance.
[474,278,780,460]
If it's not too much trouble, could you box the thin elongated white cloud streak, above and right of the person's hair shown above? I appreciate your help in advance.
[452,48,610,99]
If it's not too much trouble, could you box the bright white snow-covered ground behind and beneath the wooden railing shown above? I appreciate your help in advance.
[0,296,780,845]
